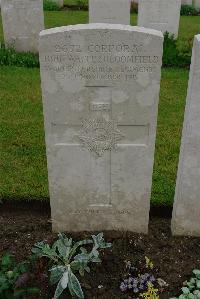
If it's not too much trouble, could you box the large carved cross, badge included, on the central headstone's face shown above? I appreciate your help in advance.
[52,86,149,207]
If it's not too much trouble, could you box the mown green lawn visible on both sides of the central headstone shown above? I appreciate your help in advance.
[0,67,188,205]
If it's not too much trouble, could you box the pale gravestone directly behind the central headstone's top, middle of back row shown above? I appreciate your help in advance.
[89,0,130,25]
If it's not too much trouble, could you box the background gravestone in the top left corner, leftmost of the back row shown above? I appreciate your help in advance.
[1,0,44,52]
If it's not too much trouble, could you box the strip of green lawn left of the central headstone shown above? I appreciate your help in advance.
[0,67,48,199]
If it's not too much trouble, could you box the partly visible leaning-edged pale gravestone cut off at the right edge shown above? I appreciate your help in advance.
[172,35,200,236]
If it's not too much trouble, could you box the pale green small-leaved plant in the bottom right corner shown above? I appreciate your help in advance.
[171,269,200,299]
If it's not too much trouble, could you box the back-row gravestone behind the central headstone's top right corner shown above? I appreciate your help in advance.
[138,0,181,37]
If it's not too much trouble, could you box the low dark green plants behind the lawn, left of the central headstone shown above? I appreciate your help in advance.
[0,44,39,68]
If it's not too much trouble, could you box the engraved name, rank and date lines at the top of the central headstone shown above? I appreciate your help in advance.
[42,37,161,86]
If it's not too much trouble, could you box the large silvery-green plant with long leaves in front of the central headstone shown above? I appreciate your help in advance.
[32,233,111,299]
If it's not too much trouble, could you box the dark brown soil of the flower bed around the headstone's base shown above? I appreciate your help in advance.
[0,203,200,299]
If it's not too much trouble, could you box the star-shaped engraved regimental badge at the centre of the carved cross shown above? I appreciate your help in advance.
[78,116,124,157]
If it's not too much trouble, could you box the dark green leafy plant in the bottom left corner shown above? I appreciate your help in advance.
[0,253,39,299]
